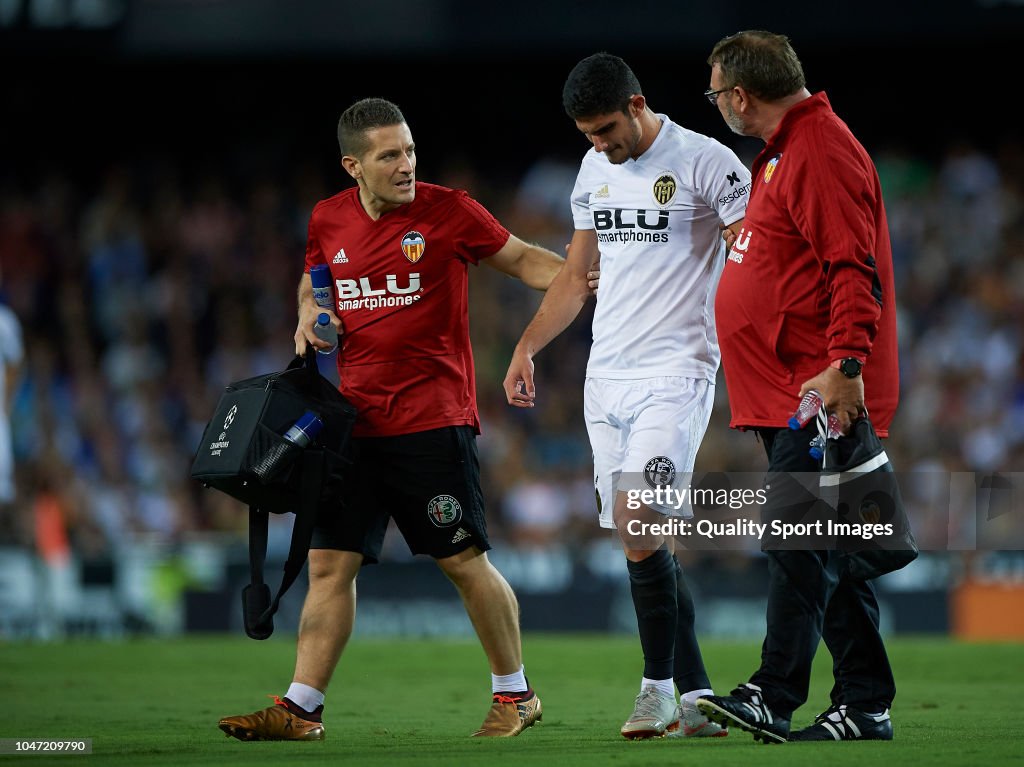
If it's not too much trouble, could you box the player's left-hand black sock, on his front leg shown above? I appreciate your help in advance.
[626,548,678,679]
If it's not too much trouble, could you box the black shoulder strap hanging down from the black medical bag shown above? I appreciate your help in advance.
[242,450,325,639]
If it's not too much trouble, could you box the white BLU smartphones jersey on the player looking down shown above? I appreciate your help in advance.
[572,115,751,381]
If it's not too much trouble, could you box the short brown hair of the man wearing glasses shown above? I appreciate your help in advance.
[708,30,806,101]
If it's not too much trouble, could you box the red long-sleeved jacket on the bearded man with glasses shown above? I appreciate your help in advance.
[715,92,899,436]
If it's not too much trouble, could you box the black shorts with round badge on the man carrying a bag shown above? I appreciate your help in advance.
[310,426,490,563]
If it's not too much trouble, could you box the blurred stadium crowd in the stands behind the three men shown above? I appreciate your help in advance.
[0,132,1024,559]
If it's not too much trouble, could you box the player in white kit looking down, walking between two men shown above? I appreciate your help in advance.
[504,53,751,738]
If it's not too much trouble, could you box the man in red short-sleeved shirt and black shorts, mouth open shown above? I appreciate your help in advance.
[220,98,562,740]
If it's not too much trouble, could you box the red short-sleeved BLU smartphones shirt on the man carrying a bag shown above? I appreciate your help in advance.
[305,182,510,436]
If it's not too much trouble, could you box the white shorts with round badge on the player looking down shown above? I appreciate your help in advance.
[584,376,715,529]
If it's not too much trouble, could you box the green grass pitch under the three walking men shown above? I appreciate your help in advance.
[0,634,1024,767]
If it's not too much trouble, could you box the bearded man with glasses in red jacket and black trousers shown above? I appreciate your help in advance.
[697,31,899,742]
